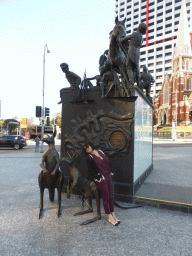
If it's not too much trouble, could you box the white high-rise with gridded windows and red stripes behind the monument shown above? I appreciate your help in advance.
[115,0,192,96]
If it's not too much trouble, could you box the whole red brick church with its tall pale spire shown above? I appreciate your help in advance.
[153,1,192,125]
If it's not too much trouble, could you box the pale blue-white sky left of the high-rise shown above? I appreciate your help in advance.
[0,0,114,118]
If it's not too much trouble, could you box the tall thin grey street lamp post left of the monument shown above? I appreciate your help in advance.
[40,44,50,153]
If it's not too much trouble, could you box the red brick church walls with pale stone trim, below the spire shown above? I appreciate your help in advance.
[153,55,192,125]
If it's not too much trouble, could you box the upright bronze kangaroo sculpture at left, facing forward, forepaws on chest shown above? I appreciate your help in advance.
[38,130,64,218]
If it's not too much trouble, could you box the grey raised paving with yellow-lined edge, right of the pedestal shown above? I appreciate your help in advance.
[135,139,192,213]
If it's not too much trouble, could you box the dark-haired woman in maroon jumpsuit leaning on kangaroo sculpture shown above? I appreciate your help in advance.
[84,142,120,226]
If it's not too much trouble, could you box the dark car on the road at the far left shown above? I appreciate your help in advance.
[0,135,27,149]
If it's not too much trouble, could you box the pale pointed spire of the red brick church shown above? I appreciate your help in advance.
[175,0,191,55]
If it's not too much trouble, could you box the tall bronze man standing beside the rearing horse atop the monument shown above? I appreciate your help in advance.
[119,23,147,90]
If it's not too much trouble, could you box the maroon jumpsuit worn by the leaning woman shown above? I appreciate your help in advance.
[91,150,114,214]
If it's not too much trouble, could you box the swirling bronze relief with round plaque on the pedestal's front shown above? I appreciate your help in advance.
[61,110,134,162]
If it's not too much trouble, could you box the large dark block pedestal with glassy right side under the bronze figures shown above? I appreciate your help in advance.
[60,87,153,202]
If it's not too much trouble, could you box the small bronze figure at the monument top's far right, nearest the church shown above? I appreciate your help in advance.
[140,66,155,100]
